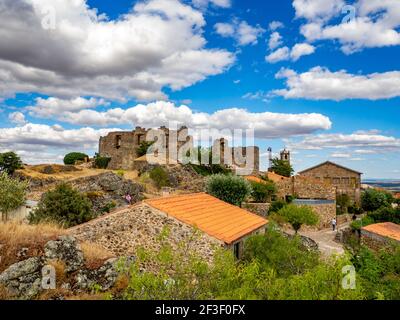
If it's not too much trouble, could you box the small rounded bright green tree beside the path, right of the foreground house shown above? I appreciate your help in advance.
[276,204,319,234]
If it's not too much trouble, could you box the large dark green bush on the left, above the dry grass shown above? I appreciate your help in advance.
[29,183,94,228]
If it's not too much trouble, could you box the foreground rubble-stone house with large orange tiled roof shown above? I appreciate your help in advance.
[69,193,268,261]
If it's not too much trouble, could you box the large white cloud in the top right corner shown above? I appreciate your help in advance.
[293,0,400,54]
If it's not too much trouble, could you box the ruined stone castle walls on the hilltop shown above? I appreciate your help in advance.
[99,127,260,175]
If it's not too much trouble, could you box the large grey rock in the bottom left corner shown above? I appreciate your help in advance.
[0,257,43,299]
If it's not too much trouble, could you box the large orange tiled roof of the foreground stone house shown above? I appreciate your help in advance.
[145,193,268,244]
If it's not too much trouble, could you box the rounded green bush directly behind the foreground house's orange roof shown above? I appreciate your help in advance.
[206,174,251,206]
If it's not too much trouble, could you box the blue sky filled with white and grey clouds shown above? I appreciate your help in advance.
[0,0,400,178]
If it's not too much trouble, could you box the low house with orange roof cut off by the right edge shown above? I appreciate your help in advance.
[361,222,400,250]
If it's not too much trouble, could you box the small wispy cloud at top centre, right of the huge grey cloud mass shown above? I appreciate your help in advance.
[214,20,265,46]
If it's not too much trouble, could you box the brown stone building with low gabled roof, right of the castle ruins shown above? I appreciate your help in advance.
[299,161,362,204]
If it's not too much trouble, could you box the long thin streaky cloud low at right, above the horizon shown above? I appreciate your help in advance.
[288,132,400,156]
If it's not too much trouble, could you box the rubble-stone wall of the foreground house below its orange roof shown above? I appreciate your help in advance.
[70,204,224,261]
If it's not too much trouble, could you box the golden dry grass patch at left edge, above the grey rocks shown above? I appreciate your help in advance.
[0,222,66,272]
